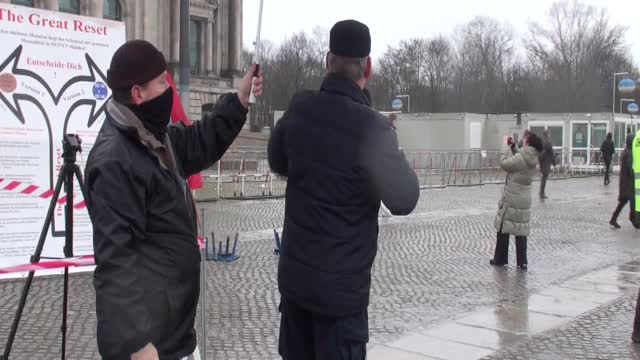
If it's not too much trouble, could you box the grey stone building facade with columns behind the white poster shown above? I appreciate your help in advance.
[0,0,242,120]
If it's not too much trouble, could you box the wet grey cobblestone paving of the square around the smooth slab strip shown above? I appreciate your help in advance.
[0,178,640,360]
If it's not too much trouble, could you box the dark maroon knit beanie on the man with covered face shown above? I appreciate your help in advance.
[107,40,167,89]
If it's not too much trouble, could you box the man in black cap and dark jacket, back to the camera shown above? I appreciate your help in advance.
[269,20,419,360]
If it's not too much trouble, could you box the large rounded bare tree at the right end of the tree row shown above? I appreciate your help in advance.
[525,1,633,111]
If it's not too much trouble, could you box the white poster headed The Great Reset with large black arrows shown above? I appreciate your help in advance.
[0,3,126,277]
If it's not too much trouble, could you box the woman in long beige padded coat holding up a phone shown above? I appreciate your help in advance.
[490,133,543,270]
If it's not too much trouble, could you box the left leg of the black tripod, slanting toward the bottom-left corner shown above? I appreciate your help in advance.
[2,173,65,360]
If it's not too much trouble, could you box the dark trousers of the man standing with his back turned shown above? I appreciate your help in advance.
[278,298,369,360]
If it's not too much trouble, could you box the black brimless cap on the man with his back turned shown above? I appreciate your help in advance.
[329,20,371,58]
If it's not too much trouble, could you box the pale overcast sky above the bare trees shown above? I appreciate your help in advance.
[243,0,640,70]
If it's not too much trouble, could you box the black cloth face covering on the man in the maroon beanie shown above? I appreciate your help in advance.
[129,88,173,142]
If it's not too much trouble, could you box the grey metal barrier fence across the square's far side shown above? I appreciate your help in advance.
[196,148,619,200]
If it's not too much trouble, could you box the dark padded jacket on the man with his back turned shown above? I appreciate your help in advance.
[269,74,419,316]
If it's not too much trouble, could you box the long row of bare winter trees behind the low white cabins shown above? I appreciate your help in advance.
[243,1,640,130]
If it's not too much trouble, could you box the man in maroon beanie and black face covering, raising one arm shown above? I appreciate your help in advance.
[86,40,262,360]
